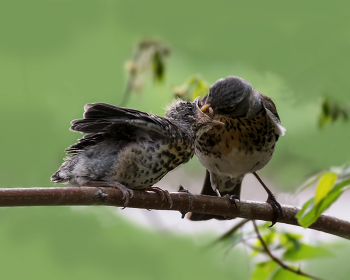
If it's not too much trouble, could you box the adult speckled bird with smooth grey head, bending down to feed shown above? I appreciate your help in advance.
[189,76,286,224]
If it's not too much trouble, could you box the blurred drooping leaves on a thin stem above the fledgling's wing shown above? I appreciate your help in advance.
[120,39,170,106]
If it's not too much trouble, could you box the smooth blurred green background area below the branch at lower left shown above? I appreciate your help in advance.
[0,206,250,280]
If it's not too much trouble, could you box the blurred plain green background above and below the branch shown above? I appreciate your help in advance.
[0,0,350,279]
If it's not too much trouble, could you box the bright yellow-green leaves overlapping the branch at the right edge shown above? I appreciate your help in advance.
[296,168,350,228]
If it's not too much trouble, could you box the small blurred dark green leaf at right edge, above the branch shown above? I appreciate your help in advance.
[318,96,350,128]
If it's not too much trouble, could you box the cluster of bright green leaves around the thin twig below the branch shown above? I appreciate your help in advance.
[216,223,332,280]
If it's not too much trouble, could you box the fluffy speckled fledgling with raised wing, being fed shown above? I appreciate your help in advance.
[51,98,223,206]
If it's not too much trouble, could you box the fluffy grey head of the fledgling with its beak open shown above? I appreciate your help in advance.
[166,98,224,137]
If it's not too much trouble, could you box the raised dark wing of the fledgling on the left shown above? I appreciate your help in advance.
[70,103,178,140]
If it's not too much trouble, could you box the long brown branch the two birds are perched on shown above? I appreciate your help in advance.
[0,187,350,239]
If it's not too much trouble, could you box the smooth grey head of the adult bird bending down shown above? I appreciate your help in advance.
[200,76,255,117]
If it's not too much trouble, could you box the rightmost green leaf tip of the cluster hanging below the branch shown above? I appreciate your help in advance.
[283,244,332,261]
